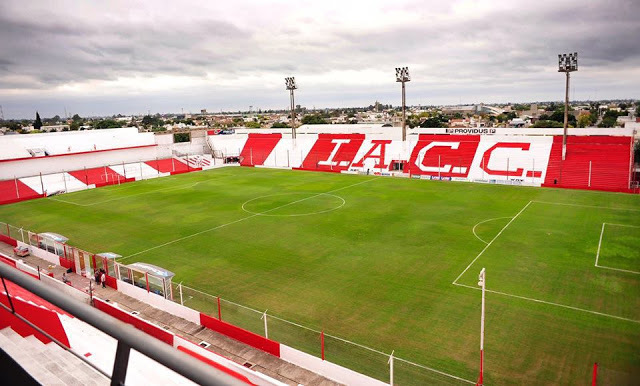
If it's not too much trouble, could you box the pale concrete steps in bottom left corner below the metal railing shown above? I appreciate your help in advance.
[0,327,109,385]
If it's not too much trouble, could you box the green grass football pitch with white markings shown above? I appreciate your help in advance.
[0,167,640,385]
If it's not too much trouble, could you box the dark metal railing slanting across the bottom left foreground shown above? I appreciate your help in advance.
[0,264,243,385]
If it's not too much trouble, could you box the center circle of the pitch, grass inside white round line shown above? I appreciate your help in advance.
[242,192,346,217]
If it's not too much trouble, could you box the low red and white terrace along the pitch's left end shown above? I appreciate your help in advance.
[0,155,213,205]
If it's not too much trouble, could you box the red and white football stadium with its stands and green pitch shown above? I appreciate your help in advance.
[0,124,640,385]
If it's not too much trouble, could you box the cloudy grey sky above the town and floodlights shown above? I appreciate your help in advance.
[0,0,640,119]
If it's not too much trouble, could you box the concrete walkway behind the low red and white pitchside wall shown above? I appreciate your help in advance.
[0,246,339,386]
